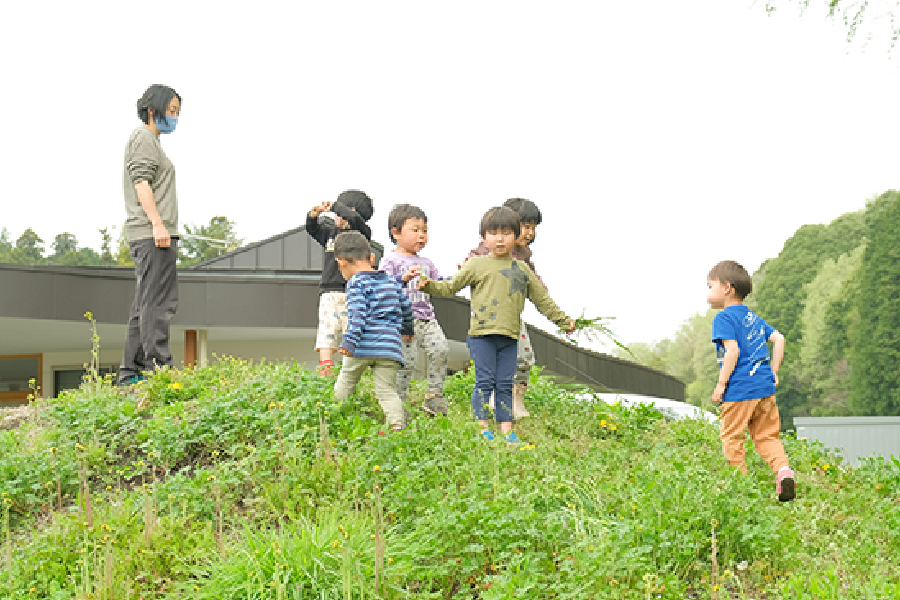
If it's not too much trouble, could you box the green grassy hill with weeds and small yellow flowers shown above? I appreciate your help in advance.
[0,359,900,600]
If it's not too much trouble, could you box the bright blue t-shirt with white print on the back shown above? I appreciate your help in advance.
[713,304,775,402]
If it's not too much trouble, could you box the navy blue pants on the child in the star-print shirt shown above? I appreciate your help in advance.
[467,335,519,423]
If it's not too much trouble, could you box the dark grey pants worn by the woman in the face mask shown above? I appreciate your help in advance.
[119,238,178,383]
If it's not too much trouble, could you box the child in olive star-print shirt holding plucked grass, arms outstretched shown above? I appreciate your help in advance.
[419,206,575,443]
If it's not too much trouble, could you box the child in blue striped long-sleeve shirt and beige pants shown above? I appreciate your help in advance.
[334,231,415,431]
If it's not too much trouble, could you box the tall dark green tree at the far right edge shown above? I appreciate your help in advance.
[850,192,900,416]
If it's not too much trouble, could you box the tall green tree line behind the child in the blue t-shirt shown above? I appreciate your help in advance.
[620,191,900,429]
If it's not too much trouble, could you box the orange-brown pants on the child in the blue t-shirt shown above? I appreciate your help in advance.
[719,396,788,473]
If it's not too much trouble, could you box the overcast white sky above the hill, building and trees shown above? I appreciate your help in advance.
[0,0,900,342]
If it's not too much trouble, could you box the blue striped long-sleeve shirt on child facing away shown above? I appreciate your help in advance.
[341,271,415,364]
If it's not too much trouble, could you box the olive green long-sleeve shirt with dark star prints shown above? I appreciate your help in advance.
[422,256,569,339]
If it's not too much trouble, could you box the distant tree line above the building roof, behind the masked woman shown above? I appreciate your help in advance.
[0,216,244,267]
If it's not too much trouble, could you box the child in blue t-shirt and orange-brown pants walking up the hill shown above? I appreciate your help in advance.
[706,260,796,502]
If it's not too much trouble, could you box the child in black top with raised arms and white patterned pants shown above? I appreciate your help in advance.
[306,190,373,375]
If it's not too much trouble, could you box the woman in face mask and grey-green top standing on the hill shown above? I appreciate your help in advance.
[118,84,181,385]
